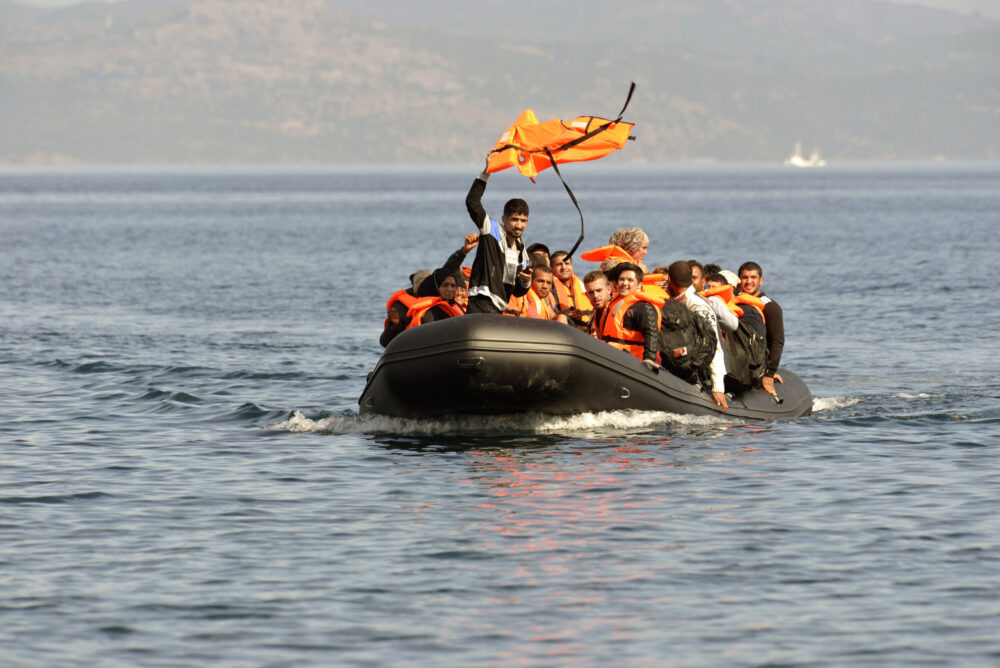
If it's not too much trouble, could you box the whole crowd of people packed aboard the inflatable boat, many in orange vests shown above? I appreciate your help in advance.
[380,167,785,411]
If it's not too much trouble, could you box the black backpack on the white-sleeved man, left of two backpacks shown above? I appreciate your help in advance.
[660,301,717,383]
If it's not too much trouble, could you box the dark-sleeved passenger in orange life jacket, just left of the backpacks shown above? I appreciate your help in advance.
[598,262,660,370]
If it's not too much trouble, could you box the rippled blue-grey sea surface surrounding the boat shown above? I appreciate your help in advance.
[0,163,1000,667]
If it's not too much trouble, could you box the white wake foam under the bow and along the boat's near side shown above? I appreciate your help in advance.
[263,411,729,436]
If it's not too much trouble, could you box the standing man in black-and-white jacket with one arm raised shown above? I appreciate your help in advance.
[465,171,531,313]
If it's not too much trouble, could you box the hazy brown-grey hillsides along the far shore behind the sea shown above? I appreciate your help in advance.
[0,0,1000,164]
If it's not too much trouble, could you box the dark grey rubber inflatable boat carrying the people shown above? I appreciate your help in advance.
[358,315,813,420]
